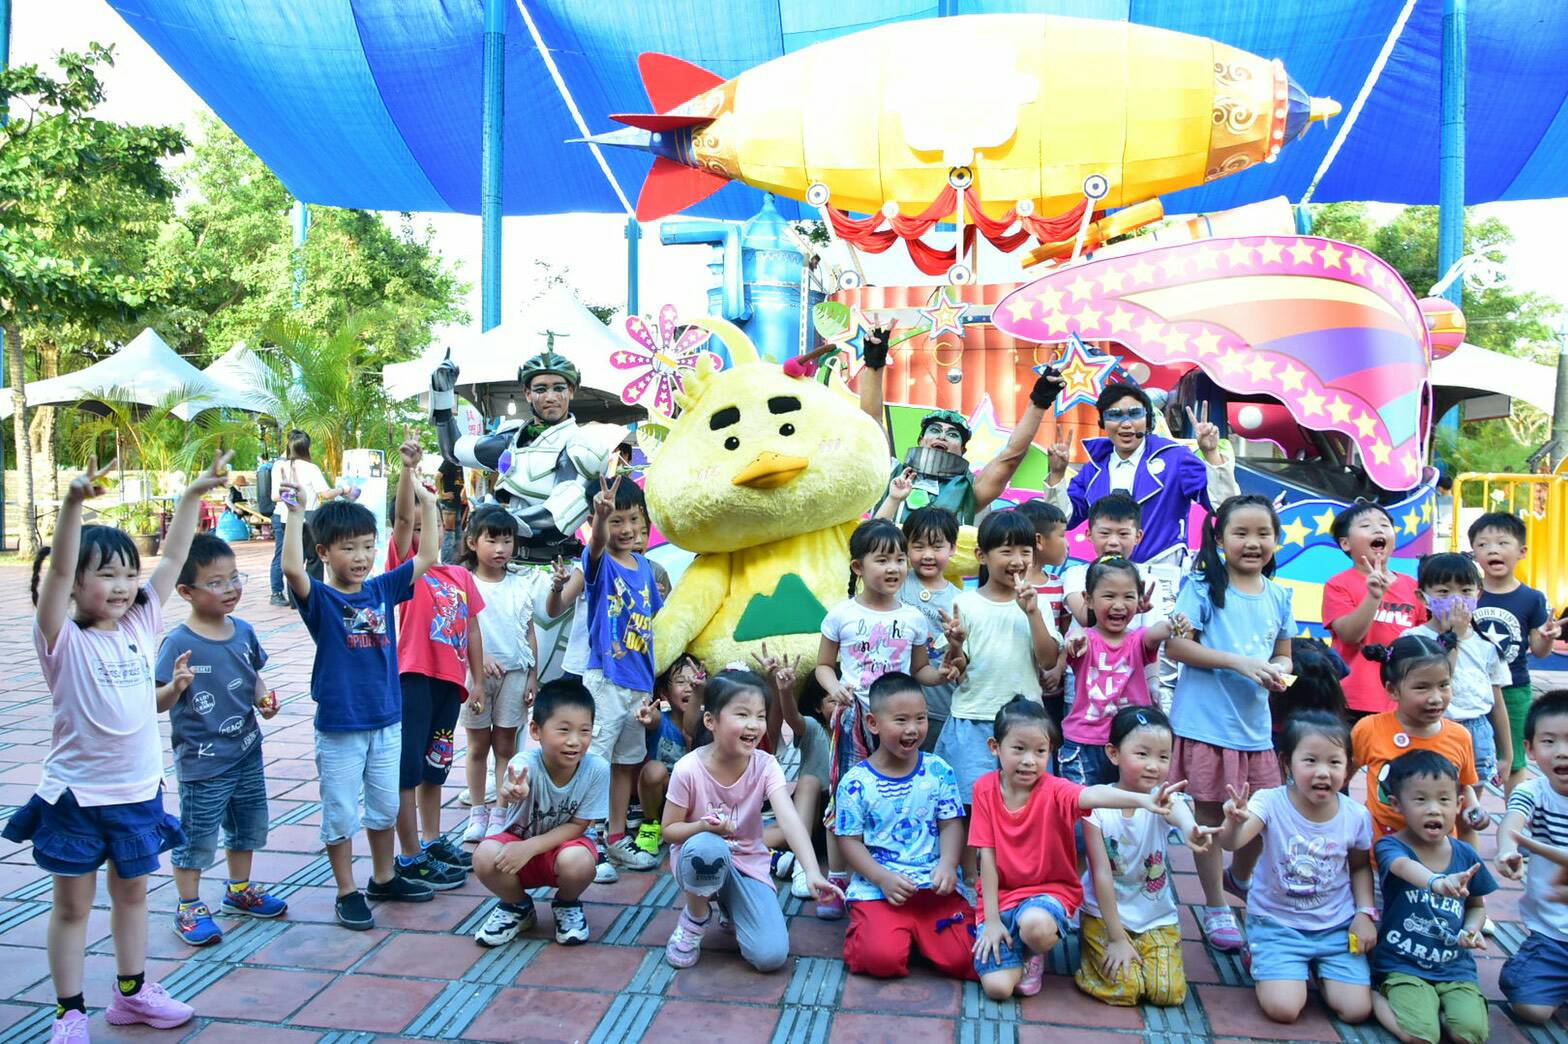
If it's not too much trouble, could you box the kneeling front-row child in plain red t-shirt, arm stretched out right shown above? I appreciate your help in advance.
[969,696,1181,1000]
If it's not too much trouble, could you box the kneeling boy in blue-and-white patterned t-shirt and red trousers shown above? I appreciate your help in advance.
[833,671,975,978]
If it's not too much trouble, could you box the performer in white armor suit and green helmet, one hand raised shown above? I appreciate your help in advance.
[430,351,627,563]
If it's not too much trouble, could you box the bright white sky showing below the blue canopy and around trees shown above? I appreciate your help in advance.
[11,0,1568,349]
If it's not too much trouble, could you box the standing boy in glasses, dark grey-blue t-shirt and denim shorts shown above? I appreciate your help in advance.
[155,533,289,947]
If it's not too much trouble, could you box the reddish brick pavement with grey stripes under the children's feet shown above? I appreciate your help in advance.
[0,544,1568,1044]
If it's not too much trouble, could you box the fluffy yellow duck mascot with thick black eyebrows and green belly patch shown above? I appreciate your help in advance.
[641,317,887,680]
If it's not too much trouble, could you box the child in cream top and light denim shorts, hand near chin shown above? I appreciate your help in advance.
[936,511,1060,804]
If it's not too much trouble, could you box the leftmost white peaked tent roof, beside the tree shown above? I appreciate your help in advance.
[0,326,257,417]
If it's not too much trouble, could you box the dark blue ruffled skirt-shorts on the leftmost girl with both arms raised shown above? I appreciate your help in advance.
[5,790,185,879]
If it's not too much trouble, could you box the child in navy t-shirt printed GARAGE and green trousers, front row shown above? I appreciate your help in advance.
[1372,751,1497,1044]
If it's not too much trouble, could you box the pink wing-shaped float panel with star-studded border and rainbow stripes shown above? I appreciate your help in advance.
[993,235,1428,491]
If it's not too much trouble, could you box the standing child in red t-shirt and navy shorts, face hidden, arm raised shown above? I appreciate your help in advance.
[386,439,485,892]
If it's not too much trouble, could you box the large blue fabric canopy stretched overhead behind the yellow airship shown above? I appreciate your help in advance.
[110,0,1568,218]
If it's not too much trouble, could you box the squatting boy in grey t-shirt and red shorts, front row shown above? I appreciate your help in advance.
[474,679,610,947]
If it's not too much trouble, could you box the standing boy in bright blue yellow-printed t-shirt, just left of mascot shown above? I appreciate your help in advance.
[582,475,665,883]
